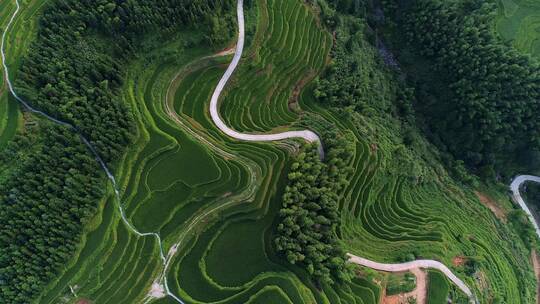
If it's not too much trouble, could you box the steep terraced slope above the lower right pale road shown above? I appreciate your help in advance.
[302,90,534,303]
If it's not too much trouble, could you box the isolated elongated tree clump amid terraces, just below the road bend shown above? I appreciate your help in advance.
[274,132,353,283]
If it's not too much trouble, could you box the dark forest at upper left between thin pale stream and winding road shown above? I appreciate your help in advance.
[16,0,234,161]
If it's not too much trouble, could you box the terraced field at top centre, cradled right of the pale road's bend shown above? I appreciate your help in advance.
[220,0,331,132]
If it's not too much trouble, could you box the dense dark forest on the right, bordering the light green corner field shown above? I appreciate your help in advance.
[399,0,540,177]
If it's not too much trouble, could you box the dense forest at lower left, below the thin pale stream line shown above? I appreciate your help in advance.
[0,126,105,304]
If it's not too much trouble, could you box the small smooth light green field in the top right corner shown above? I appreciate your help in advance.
[497,0,540,57]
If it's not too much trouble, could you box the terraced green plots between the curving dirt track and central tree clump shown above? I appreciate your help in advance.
[168,58,378,303]
